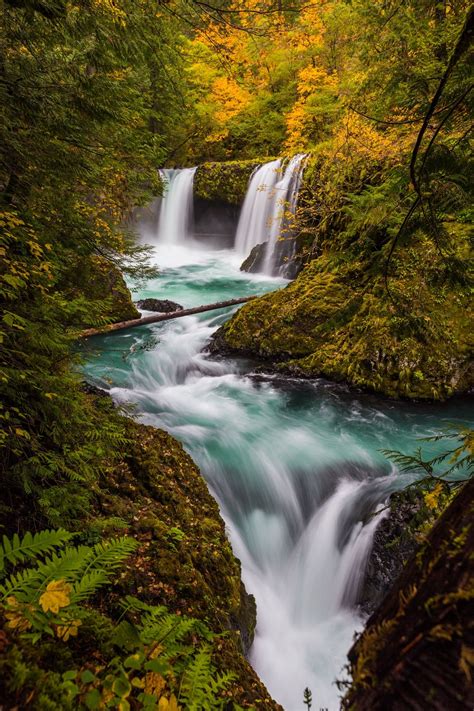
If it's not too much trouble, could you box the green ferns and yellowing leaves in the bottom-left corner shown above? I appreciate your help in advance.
[0,531,234,711]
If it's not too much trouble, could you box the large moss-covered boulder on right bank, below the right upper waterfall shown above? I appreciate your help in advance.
[214,231,474,399]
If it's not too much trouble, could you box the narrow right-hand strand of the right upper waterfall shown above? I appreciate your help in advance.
[262,153,306,275]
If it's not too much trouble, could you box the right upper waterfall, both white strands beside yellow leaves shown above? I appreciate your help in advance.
[235,154,306,276]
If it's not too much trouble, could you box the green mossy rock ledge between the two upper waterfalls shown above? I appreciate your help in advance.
[194,159,262,205]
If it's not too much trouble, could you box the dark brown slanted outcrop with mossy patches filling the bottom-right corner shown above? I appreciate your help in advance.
[341,479,474,711]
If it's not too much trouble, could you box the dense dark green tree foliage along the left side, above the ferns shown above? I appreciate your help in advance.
[0,0,188,528]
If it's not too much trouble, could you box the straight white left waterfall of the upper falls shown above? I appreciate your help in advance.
[157,168,196,245]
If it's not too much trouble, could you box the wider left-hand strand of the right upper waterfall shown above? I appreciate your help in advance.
[235,159,281,258]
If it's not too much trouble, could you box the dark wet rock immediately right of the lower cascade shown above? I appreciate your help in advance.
[358,491,423,614]
